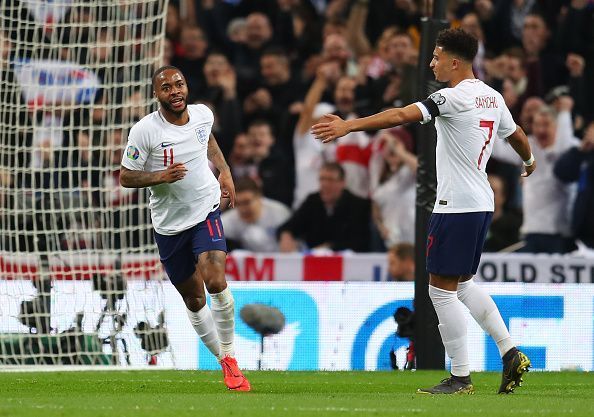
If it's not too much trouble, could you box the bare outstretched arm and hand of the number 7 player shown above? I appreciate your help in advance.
[311,104,423,143]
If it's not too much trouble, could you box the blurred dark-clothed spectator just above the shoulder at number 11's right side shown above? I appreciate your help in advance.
[198,51,242,157]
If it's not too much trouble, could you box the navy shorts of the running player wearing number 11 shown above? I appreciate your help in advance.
[155,209,227,284]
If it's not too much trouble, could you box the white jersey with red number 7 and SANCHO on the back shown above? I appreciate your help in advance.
[415,79,516,213]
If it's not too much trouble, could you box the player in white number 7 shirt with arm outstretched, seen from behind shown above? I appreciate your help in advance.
[312,29,536,394]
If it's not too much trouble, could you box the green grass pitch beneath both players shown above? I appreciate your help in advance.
[0,371,594,417]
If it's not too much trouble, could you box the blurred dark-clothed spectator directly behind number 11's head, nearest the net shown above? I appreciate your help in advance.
[172,25,208,100]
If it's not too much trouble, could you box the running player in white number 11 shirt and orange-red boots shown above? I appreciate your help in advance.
[120,66,250,391]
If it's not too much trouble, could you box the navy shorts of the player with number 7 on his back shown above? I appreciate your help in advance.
[427,211,493,276]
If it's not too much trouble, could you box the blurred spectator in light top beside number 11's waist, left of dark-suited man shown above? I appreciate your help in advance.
[221,178,291,252]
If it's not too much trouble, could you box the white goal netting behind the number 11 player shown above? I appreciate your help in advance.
[0,0,172,364]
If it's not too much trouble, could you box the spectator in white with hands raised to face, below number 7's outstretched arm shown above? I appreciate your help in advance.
[370,127,418,251]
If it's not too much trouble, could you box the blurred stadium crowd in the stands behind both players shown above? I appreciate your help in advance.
[0,0,594,253]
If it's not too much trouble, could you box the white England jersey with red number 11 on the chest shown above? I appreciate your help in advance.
[122,104,221,235]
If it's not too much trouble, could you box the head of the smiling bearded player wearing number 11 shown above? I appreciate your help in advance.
[153,69,188,116]
